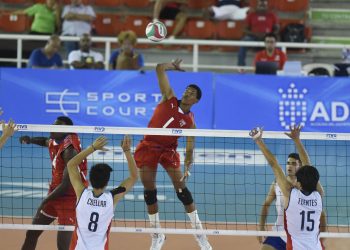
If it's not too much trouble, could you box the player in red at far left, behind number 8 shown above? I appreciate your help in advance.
[20,116,88,250]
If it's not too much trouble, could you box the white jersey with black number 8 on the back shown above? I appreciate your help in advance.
[70,189,114,250]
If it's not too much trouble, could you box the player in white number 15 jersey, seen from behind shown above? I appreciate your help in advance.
[250,126,324,250]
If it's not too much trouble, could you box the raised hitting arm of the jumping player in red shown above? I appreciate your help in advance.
[156,59,183,101]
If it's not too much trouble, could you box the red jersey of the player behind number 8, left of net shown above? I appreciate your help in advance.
[49,134,88,196]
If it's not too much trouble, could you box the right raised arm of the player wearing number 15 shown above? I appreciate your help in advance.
[285,124,324,196]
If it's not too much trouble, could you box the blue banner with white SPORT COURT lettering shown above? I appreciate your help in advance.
[0,68,214,129]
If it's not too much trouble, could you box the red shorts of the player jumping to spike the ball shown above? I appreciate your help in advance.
[134,141,180,168]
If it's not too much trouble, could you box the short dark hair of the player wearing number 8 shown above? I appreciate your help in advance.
[90,163,113,188]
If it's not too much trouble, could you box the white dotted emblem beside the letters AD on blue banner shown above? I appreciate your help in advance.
[278,83,308,129]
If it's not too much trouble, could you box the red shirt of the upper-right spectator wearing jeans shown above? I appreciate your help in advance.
[246,12,278,34]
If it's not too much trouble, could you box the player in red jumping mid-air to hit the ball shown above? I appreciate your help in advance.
[134,59,212,250]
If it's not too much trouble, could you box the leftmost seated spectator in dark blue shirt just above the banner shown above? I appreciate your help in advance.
[28,35,63,69]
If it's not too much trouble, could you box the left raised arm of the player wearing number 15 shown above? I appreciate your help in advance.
[249,128,292,206]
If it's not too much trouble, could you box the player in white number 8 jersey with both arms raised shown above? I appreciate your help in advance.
[67,136,138,250]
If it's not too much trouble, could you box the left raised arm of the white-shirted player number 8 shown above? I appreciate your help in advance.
[67,136,108,200]
